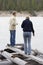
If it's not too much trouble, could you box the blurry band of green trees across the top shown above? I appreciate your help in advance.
[0,0,43,11]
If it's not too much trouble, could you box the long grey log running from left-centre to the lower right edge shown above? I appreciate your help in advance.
[4,47,43,64]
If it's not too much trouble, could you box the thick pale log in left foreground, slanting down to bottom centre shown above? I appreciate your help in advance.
[2,51,27,65]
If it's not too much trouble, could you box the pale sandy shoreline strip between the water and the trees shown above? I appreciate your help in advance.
[0,11,43,17]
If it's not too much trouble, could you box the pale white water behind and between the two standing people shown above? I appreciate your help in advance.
[0,16,43,52]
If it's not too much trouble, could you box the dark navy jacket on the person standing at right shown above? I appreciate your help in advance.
[21,19,34,34]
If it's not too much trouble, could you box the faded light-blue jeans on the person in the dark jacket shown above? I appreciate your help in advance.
[23,32,31,54]
